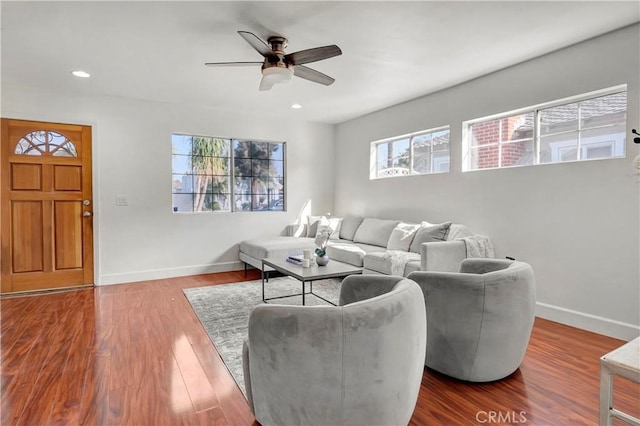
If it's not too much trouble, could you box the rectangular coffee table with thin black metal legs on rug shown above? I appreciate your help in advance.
[262,258,362,306]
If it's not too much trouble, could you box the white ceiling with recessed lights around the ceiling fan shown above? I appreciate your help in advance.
[1,1,640,123]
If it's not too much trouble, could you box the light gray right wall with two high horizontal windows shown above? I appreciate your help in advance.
[335,25,640,339]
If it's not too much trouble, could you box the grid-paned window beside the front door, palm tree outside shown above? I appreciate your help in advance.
[172,134,285,212]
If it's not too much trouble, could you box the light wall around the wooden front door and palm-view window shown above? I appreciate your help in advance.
[2,85,334,284]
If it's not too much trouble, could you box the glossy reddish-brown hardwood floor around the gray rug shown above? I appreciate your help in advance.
[0,270,640,425]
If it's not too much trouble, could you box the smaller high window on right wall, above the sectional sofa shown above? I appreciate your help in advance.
[370,127,449,179]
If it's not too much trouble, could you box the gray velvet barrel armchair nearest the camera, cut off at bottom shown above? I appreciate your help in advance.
[243,275,426,425]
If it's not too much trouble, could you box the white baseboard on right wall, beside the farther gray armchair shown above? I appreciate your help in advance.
[536,302,640,341]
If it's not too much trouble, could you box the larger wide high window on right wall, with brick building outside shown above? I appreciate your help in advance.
[463,86,627,171]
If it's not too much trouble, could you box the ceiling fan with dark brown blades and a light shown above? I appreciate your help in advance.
[205,31,342,91]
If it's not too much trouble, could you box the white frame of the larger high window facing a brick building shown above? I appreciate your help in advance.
[462,84,629,173]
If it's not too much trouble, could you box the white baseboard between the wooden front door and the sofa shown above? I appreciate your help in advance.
[96,261,244,286]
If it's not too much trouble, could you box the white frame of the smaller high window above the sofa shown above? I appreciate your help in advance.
[369,125,451,180]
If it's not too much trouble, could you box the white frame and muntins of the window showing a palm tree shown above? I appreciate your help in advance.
[171,132,287,214]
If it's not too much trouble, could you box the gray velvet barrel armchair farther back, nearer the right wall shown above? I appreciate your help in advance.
[408,258,536,382]
